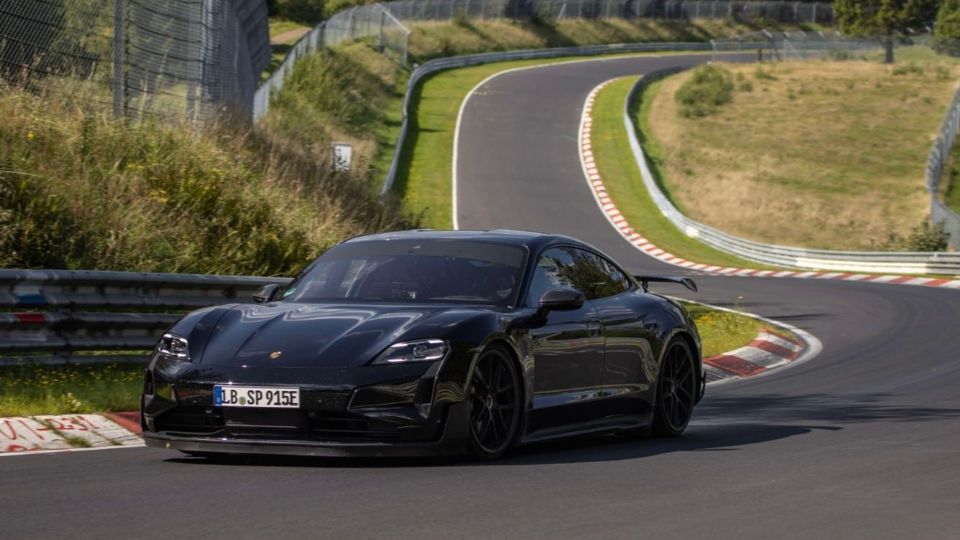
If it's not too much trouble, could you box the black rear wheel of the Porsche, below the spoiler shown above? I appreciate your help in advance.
[653,339,697,437]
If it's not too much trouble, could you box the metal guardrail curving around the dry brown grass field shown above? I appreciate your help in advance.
[623,68,960,274]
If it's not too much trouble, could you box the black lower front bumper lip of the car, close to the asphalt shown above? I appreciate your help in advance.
[143,402,469,457]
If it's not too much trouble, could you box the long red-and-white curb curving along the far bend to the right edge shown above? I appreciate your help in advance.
[578,79,960,290]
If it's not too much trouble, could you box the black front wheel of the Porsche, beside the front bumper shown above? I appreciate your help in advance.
[468,346,523,459]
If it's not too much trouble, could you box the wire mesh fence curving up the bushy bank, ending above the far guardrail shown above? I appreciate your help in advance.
[253,4,410,121]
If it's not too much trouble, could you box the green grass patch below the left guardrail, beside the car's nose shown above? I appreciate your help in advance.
[0,364,143,417]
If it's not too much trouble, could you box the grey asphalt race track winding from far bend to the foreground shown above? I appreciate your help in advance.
[0,56,960,540]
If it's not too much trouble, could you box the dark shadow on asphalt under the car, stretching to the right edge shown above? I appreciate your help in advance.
[166,394,960,468]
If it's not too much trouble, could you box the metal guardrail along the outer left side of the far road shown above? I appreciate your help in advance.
[380,42,712,195]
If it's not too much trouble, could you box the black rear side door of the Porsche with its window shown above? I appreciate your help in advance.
[589,253,657,421]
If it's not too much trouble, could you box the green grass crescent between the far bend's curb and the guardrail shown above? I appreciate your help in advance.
[591,77,763,268]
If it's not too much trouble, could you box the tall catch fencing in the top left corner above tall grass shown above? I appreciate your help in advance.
[0,0,270,121]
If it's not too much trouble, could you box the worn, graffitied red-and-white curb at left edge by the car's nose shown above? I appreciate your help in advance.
[0,413,143,457]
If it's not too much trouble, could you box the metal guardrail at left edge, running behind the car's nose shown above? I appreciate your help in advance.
[0,270,289,364]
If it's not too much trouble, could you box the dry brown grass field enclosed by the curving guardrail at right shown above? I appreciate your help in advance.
[646,61,958,249]
